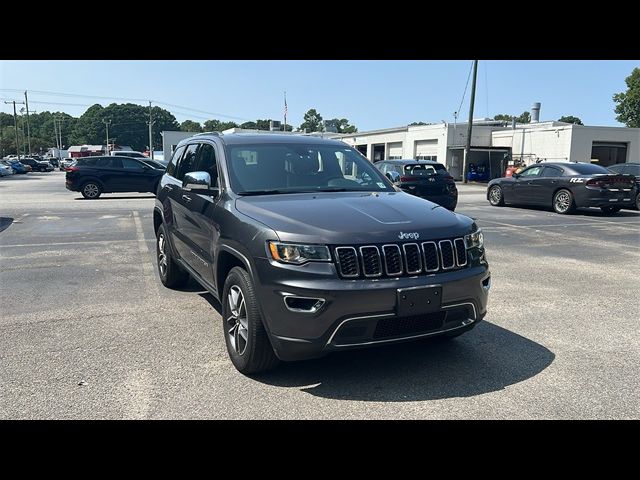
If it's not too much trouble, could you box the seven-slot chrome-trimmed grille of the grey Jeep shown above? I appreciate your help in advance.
[335,238,467,278]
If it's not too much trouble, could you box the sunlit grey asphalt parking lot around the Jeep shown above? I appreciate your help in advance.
[0,171,640,419]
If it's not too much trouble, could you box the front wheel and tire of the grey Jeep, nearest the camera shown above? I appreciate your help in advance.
[221,267,280,375]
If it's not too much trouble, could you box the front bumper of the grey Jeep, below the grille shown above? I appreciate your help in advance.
[255,259,491,360]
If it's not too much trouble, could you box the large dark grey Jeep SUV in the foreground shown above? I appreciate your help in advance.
[153,133,491,374]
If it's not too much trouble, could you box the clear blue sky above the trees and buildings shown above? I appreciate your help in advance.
[0,60,640,131]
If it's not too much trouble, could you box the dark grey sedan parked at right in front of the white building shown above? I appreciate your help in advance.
[487,162,638,214]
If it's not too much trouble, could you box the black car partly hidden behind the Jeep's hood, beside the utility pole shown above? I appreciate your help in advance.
[375,160,458,212]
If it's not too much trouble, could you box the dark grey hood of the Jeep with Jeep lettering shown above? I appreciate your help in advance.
[236,192,473,245]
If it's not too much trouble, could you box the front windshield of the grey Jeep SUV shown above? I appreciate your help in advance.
[227,143,395,195]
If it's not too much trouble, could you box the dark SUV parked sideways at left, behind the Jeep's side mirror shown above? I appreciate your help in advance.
[65,157,164,199]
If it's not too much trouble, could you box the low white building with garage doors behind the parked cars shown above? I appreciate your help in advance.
[338,120,640,179]
